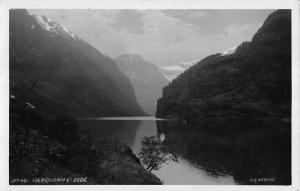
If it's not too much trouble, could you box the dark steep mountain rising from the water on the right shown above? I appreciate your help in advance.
[156,10,291,121]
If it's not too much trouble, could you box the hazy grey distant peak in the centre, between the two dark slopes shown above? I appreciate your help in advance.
[115,54,168,114]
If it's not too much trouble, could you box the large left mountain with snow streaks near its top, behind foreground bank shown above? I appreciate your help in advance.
[9,10,143,116]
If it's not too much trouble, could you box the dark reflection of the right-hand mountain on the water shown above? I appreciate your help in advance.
[157,121,291,185]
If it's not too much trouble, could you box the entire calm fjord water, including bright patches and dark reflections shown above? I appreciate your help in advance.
[79,116,290,185]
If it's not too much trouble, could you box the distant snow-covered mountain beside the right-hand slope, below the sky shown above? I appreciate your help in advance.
[159,60,199,82]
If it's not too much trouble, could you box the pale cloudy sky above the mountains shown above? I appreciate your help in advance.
[29,9,274,66]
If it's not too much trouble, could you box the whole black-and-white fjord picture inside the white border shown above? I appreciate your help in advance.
[0,1,299,189]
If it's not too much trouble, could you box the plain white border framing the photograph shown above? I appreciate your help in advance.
[0,0,300,191]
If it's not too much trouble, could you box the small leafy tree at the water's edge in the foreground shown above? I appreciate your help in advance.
[139,136,178,172]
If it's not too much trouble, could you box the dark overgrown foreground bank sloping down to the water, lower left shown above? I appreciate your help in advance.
[9,97,162,185]
